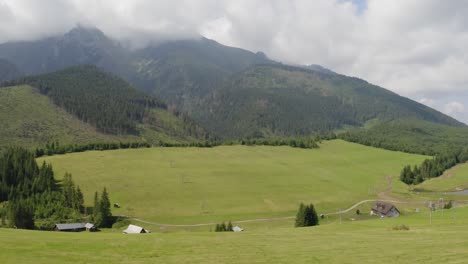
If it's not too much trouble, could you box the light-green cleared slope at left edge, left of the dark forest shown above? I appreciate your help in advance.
[0,86,117,150]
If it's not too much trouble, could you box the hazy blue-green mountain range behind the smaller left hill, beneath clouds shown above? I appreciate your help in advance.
[0,27,466,153]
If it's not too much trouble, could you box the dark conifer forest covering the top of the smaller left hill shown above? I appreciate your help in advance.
[3,65,167,135]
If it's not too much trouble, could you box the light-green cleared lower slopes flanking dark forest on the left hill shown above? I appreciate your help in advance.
[0,85,204,151]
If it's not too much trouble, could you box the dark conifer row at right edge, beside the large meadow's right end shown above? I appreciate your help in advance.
[400,148,468,184]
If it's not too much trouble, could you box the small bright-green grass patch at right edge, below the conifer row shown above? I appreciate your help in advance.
[416,163,468,192]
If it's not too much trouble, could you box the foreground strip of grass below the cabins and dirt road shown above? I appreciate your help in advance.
[0,204,468,264]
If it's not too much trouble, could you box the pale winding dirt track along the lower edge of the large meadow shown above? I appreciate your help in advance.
[119,199,424,227]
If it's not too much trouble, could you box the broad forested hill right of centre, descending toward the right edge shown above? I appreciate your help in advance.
[194,65,463,137]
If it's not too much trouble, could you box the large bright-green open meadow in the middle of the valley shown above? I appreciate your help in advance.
[39,140,426,224]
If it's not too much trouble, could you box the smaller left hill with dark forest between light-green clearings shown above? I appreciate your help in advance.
[0,65,206,150]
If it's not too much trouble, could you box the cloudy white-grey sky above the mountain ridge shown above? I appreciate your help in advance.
[0,0,468,123]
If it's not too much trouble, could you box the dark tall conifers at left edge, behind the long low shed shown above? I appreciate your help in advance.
[0,148,112,230]
